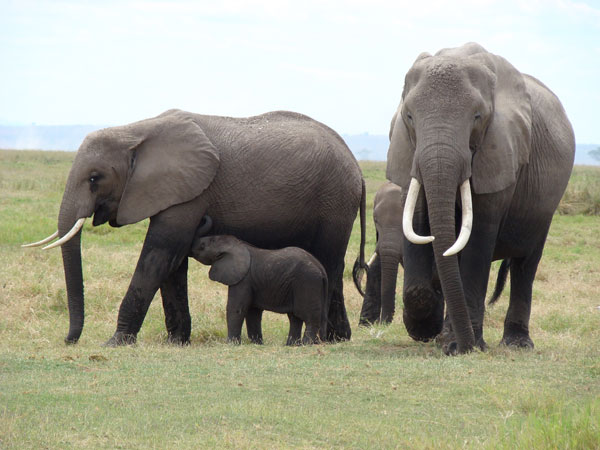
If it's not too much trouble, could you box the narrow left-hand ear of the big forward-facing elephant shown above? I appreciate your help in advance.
[385,104,415,189]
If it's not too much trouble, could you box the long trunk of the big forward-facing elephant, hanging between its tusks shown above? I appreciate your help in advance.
[418,139,475,353]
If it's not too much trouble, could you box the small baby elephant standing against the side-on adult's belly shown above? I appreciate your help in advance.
[191,235,327,345]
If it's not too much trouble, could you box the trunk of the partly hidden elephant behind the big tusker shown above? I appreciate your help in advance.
[377,230,402,323]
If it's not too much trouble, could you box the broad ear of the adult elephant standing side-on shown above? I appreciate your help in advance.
[117,110,219,225]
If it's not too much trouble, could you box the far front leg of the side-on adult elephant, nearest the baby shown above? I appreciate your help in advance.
[160,258,192,345]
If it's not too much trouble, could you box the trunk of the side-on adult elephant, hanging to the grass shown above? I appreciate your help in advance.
[58,181,84,344]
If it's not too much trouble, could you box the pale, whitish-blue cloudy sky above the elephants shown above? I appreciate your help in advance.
[0,0,600,143]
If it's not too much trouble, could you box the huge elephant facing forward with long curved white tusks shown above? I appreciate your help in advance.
[387,43,575,354]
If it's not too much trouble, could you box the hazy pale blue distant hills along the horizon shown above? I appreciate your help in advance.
[0,125,600,166]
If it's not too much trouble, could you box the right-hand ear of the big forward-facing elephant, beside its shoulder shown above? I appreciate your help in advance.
[471,52,531,194]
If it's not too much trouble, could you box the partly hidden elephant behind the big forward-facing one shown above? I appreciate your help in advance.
[355,181,404,325]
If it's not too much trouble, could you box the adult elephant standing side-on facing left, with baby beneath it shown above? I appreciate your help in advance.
[25,110,364,345]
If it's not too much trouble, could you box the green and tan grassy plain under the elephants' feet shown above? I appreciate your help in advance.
[0,151,600,449]
